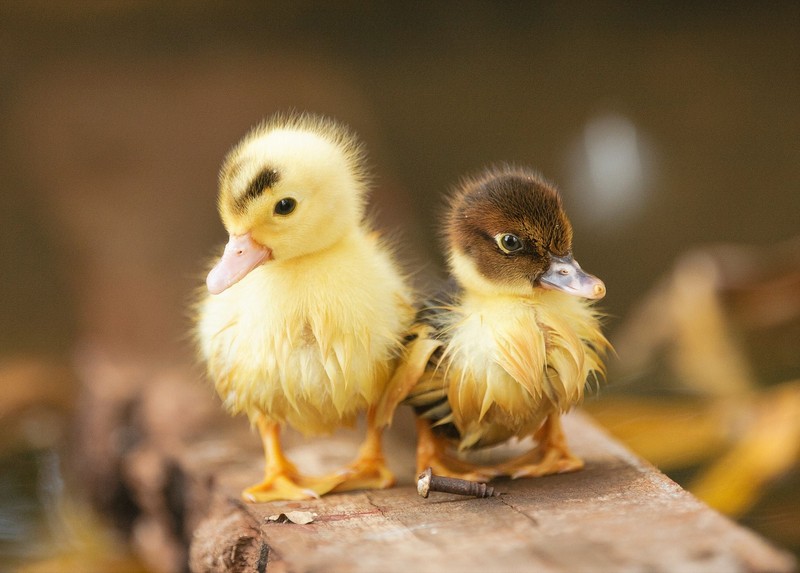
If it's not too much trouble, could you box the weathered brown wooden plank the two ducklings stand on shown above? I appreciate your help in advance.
[73,354,795,572]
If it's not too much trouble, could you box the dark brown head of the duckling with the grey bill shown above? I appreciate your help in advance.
[446,166,606,299]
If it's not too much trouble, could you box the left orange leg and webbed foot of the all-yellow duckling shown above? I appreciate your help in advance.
[242,416,337,502]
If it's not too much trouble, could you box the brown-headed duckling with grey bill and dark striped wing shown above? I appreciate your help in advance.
[382,166,610,480]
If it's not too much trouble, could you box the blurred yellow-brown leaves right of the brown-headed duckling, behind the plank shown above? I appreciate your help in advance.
[590,238,800,515]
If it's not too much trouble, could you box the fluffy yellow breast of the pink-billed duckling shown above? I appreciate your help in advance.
[198,237,411,434]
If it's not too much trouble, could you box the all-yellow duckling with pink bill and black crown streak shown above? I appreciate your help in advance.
[196,114,414,502]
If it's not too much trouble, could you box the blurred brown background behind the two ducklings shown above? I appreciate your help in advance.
[0,0,800,571]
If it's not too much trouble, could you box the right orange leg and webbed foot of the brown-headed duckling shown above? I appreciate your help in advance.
[497,413,583,478]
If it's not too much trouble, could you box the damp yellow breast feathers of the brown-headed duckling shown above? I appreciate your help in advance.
[422,293,607,449]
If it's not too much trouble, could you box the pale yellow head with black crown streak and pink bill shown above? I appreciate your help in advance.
[206,114,367,294]
